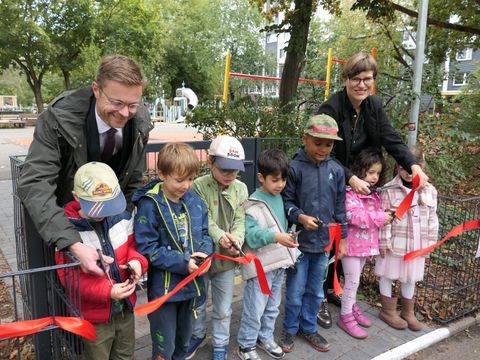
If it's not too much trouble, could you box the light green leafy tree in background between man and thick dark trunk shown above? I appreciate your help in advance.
[156,0,264,99]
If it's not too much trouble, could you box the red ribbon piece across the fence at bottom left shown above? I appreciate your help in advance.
[0,316,97,341]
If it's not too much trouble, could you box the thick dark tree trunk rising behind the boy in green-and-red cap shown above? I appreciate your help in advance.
[280,0,313,112]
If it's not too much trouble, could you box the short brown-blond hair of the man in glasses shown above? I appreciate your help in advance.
[96,54,147,88]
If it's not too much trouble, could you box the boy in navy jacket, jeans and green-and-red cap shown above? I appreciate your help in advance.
[280,114,346,353]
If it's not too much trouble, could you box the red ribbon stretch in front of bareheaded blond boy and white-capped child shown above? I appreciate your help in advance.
[135,253,272,316]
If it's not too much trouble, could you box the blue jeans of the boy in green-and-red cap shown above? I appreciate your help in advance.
[283,253,328,334]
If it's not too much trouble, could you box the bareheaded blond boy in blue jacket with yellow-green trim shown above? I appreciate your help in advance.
[133,143,213,360]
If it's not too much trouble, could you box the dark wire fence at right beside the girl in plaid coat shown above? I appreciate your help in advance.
[362,196,480,324]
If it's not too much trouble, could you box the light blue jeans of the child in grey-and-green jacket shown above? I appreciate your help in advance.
[237,269,285,348]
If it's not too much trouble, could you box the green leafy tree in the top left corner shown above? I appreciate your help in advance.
[0,0,98,111]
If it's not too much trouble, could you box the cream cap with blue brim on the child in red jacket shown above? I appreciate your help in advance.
[73,162,127,218]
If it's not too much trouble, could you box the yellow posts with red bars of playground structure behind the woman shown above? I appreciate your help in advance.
[223,48,377,104]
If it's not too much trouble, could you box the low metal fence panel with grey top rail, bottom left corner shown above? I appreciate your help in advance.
[0,253,81,360]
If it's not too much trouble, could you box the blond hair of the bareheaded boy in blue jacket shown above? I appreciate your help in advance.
[157,143,200,177]
